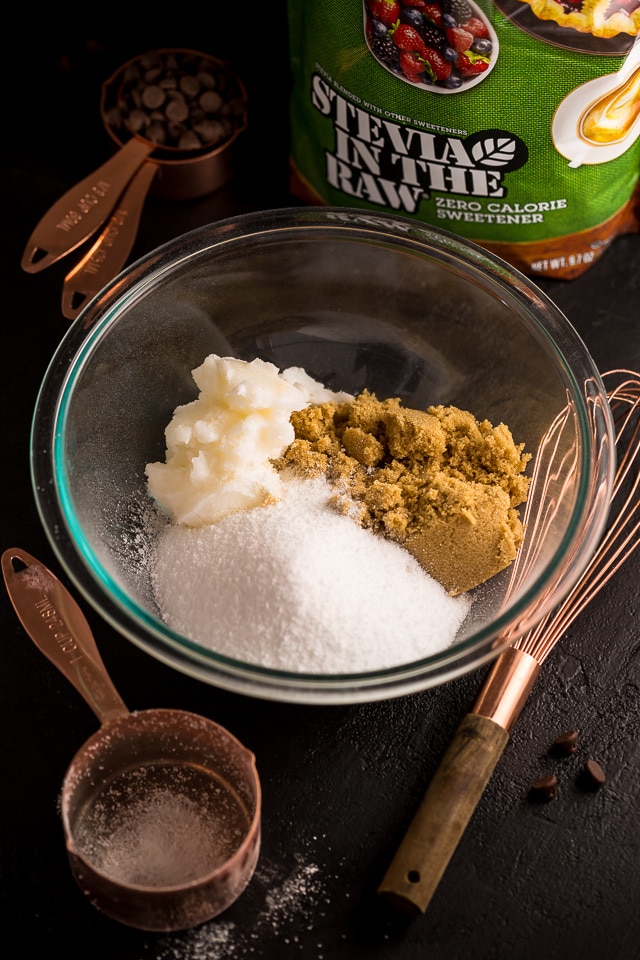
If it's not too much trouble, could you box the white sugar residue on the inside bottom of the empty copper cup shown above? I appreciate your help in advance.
[73,763,251,887]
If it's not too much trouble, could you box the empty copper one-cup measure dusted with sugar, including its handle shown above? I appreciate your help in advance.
[2,548,261,931]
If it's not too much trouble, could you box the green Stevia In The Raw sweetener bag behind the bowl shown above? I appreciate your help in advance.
[288,0,640,279]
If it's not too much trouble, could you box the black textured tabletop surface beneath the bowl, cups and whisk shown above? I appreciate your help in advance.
[0,13,640,960]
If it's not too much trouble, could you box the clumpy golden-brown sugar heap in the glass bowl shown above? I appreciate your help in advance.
[275,391,531,595]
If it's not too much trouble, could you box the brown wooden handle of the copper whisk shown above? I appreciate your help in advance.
[378,713,509,915]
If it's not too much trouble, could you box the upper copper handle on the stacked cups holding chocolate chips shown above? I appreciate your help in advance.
[21,137,152,273]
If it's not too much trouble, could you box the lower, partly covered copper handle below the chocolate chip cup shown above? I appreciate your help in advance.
[62,160,158,320]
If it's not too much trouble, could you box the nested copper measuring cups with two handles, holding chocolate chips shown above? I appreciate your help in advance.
[21,48,247,320]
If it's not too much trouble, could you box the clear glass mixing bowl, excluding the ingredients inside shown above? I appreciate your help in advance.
[31,207,615,703]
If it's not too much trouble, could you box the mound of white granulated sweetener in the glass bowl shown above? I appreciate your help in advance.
[153,478,471,674]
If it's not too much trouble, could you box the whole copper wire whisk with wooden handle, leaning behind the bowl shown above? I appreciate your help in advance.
[378,370,640,915]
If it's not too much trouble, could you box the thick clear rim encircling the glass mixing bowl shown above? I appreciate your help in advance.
[31,206,615,704]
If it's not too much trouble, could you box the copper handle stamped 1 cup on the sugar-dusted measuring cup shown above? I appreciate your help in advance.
[2,547,129,724]
